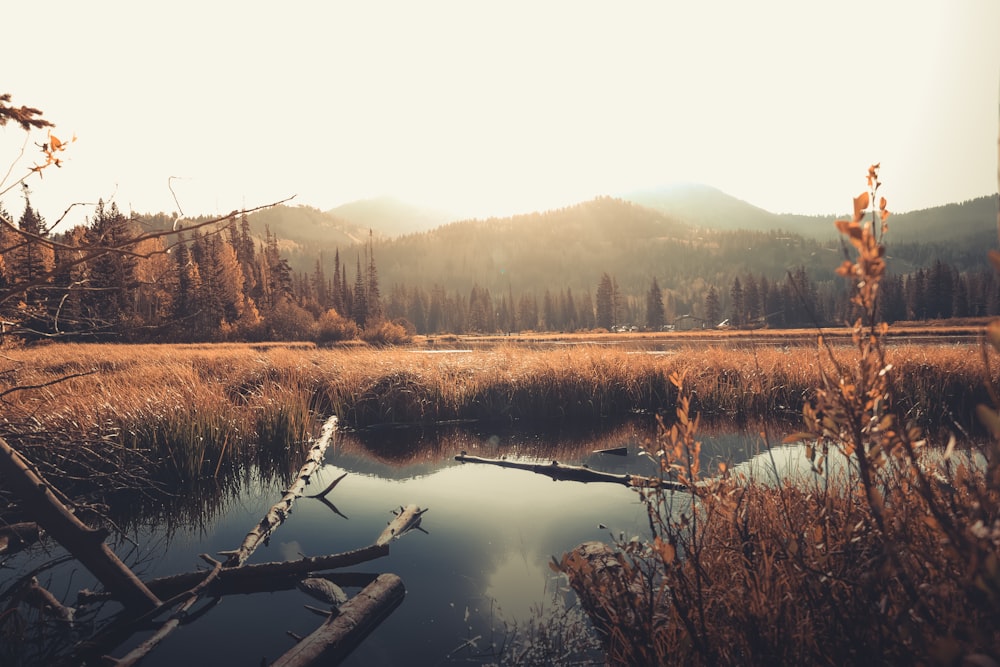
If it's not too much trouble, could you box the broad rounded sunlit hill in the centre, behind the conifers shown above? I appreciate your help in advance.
[364,197,839,298]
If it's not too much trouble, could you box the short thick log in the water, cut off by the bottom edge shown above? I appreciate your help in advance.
[271,574,406,667]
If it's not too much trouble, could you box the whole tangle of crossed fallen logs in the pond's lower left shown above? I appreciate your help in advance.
[0,417,418,667]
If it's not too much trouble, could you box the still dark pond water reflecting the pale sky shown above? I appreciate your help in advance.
[0,418,780,666]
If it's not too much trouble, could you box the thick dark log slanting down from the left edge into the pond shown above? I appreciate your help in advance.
[0,438,160,612]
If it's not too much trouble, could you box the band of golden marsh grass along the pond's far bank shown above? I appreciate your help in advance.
[0,336,998,494]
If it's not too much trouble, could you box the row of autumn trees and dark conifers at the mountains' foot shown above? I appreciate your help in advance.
[0,190,1000,343]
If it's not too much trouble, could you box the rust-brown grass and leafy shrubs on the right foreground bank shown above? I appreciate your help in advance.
[554,166,1000,665]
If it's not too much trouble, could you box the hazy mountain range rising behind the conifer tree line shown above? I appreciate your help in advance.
[242,185,997,294]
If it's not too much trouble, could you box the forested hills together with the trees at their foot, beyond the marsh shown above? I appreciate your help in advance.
[0,189,1000,341]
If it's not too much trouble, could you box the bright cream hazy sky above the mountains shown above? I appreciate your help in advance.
[0,0,1000,227]
